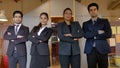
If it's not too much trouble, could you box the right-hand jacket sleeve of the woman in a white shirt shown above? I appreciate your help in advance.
[35,28,52,42]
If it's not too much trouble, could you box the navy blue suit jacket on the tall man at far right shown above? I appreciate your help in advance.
[83,18,112,54]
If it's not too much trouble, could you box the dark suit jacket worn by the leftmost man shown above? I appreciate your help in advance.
[4,25,29,56]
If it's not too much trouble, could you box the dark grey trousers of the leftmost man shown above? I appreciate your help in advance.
[8,56,27,68]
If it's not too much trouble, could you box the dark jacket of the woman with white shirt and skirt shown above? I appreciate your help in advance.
[28,27,52,55]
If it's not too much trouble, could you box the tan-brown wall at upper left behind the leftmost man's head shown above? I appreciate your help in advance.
[0,0,47,23]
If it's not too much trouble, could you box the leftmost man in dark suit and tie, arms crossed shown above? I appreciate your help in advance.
[4,11,29,68]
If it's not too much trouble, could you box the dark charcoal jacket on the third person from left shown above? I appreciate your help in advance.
[58,22,83,55]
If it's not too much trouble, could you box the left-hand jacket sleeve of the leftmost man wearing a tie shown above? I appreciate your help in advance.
[4,26,17,40]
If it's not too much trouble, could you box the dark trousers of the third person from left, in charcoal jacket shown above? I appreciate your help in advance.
[59,54,81,68]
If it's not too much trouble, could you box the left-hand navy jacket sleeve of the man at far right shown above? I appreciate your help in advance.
[82,23,98,39]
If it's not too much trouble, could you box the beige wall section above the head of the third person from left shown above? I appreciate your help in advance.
[50,0,74,17]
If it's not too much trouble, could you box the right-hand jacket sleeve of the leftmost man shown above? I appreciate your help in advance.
[14,27,29,44]
